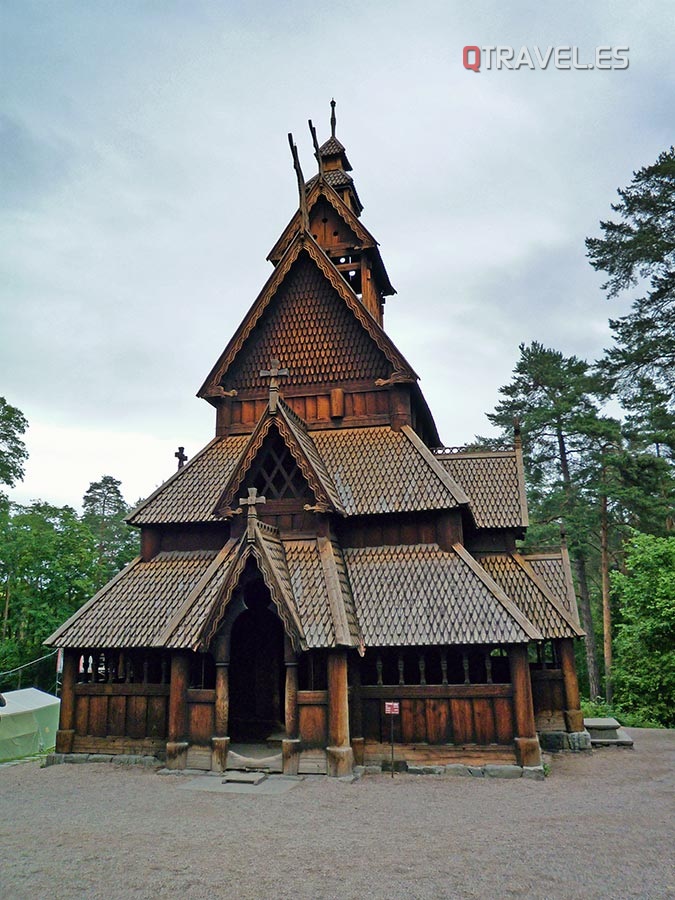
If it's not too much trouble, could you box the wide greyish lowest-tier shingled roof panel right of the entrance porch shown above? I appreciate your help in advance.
[343,544,541,647]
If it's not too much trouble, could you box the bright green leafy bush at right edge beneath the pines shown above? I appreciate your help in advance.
[612,534,675,727]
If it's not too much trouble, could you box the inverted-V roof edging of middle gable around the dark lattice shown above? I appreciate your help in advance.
[214,400,346,516]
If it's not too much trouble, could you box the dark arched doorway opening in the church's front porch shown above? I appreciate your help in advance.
[229,578,285,742]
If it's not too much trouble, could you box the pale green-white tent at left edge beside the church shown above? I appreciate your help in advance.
[0,688,61,762]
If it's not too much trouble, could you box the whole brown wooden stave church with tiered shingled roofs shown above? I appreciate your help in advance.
[46,105,583,775]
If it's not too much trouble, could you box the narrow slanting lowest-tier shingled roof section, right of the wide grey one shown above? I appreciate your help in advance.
[476,553,583,638]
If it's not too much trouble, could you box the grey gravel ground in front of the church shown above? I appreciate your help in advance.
[0,729,675,900]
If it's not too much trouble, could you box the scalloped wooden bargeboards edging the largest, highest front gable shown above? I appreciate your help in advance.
[198,233,417,398]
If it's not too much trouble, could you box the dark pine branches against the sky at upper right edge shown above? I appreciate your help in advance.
[586,147,675,398]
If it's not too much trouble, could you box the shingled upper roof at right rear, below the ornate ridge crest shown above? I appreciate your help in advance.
[434,450,528,528]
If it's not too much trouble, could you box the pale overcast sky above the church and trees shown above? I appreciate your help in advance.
[0,0,675,507]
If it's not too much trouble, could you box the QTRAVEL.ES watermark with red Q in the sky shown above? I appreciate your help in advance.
[462,44,630,72]
